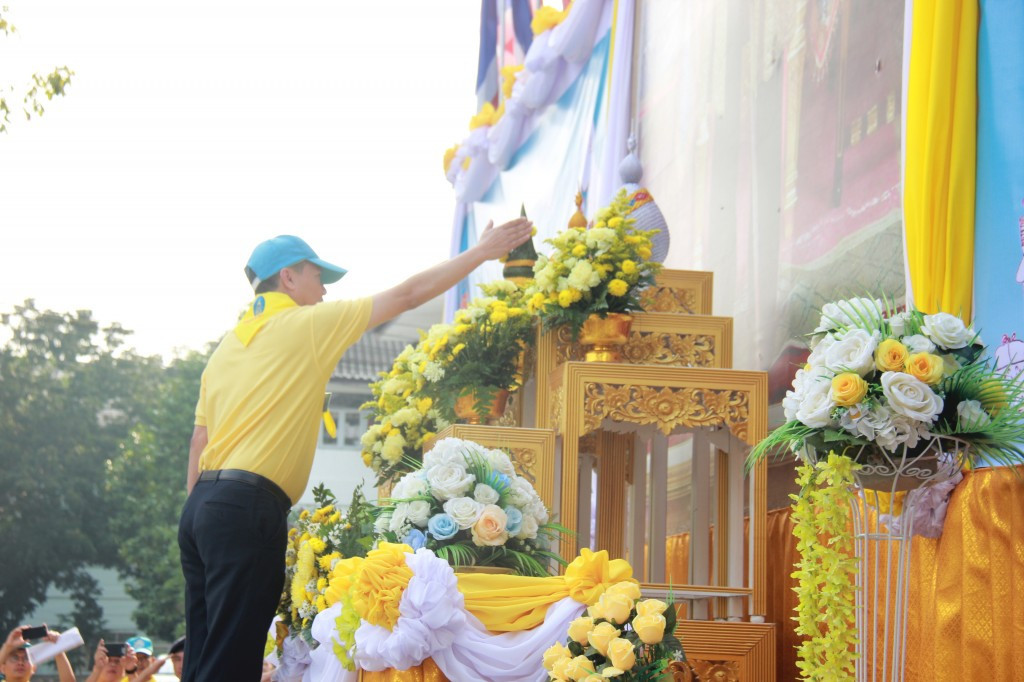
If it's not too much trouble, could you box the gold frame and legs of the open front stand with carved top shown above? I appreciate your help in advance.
[538,361,768,613]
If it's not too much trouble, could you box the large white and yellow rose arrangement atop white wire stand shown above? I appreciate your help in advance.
[750,298,1024,464]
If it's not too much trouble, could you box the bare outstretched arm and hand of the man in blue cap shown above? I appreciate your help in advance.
[368,218,534,329]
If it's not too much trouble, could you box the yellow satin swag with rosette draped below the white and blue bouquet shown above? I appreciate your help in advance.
[456,548,635,632]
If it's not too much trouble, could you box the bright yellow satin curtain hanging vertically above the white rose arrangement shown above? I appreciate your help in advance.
[903,0,978,321]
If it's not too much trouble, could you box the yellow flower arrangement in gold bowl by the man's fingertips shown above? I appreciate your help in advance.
[526,190,660,338]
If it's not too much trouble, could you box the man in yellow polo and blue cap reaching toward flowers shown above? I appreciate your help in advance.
[178,218,531,682]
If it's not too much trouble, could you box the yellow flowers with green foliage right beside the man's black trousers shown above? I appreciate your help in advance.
[278,485,374,644]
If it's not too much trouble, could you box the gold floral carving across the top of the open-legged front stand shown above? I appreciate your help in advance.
[584,382,750,437]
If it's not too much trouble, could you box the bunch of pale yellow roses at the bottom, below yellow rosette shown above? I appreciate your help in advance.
[544,581,684,682]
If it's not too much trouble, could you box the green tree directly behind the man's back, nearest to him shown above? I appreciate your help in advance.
[108,352,208,640]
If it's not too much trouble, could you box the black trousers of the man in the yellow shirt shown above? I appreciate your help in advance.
[178,480,289,682]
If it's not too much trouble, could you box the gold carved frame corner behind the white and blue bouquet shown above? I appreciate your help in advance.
[423,424,555,509]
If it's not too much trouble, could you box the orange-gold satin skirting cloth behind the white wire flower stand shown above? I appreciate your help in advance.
[679,467,1024,682]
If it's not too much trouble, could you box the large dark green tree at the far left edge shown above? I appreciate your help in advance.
[0,300,162,655]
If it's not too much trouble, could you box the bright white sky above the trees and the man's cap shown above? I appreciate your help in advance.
[0,0,481,354]
